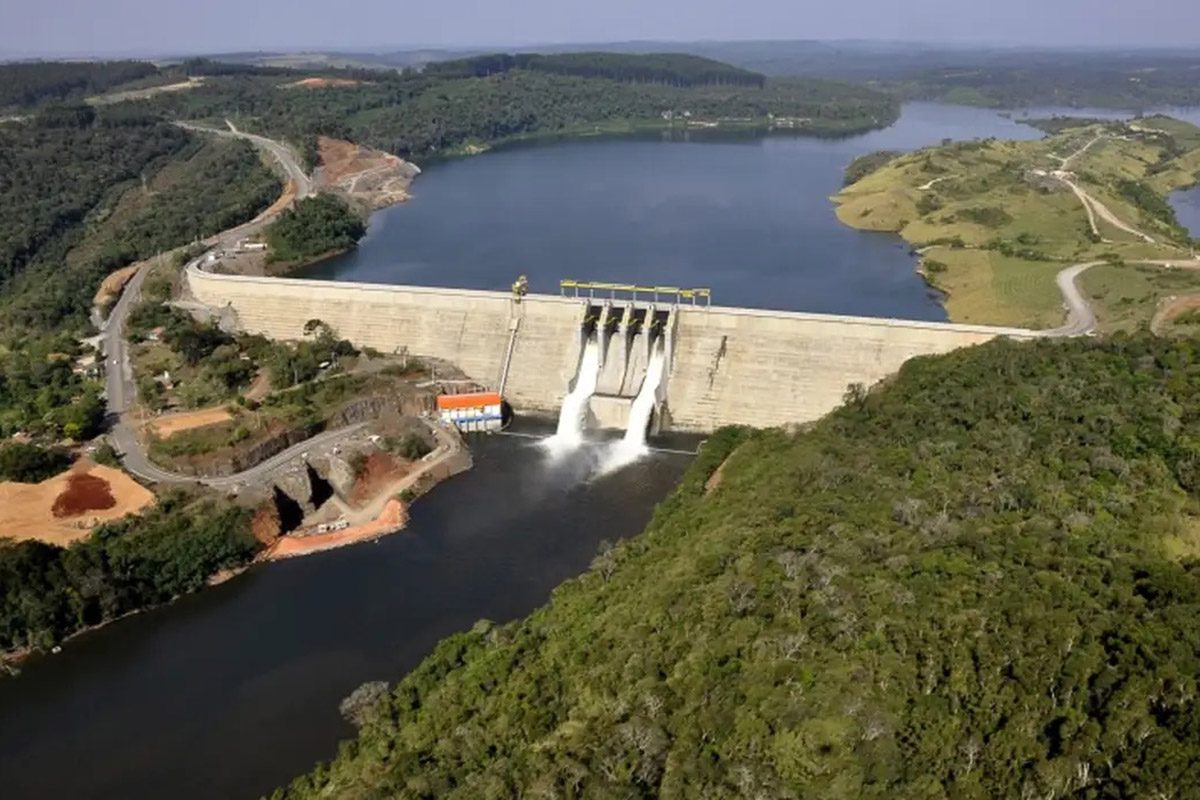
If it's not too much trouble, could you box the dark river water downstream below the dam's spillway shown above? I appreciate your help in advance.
[0,437,690,800]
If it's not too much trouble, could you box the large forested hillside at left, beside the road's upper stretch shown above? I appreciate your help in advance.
[0,104,280,338]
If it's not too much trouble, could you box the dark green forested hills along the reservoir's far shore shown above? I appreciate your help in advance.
[133,67,899,160]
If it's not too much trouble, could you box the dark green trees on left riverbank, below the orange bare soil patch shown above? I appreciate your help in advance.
[0,492,259,651]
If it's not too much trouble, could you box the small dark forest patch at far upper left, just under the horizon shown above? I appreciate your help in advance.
[0,61,160,110]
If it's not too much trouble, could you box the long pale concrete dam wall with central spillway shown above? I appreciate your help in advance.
[186,265,1038,432]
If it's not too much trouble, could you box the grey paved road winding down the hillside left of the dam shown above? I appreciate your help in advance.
[101,120,348,489]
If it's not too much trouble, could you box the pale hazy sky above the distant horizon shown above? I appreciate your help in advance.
[0,0,1200,56]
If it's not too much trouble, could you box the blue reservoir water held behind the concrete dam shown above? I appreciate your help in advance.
[307,103,1075,319]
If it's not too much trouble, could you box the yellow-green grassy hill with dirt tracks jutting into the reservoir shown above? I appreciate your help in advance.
[835,118,1200,327]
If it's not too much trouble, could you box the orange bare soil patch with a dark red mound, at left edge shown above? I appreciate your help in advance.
[0,461,154,546]
